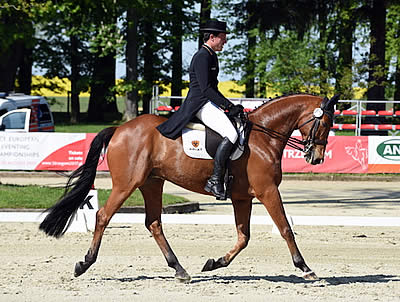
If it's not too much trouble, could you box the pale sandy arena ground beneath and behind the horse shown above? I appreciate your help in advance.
[0,173,400,301]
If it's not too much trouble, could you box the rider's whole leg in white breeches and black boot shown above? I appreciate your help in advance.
[196,102,238,199]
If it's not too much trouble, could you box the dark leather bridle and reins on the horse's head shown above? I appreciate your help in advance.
[252,103,333,154]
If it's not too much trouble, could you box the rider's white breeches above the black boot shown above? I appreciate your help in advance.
[196,101,238,144]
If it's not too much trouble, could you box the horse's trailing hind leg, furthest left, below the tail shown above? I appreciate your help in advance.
[74,187,134,277]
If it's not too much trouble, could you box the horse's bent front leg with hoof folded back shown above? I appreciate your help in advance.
[202,199,252,272]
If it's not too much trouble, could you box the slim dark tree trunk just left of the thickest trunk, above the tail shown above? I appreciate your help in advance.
[70,35,80,124]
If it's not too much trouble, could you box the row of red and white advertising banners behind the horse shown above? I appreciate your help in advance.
[0,132,400,173]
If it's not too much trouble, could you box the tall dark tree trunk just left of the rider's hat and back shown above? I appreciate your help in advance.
[171,1,183,107]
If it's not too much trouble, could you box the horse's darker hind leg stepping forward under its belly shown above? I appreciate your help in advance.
[139,178,191,282]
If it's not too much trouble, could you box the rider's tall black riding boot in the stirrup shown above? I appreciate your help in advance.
[204,137,233,200]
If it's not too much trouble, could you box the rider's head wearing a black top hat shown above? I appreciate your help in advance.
[200,20,228,51]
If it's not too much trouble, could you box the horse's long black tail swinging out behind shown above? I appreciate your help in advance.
[39,127,117,238]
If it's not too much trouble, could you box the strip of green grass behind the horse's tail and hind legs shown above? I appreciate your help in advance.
[0,184,188,209]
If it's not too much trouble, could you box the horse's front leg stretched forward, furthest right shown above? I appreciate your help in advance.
[257,185,318,280]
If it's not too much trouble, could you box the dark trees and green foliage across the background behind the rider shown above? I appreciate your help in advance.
[0,0,400,123]
